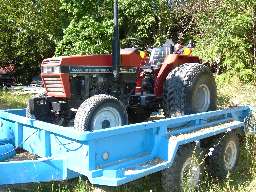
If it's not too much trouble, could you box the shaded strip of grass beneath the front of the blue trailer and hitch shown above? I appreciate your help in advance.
[3,173,162,192]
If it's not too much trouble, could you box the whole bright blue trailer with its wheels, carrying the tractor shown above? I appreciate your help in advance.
[0,106,256,191]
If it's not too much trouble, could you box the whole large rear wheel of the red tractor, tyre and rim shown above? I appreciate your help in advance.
[163,63,216,117]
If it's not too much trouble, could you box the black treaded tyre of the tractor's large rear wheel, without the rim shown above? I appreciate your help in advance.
[163,63,216,117]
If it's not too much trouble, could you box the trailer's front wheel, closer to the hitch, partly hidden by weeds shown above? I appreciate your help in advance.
[161,144,203,192]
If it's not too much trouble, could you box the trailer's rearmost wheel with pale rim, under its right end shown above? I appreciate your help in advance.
[207,133,240,178]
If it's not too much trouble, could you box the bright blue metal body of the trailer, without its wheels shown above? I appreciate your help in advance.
[0,106,251,186]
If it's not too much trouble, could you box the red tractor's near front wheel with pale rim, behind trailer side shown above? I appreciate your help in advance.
[74,94,128,131]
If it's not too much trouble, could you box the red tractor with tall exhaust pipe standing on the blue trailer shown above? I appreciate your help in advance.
[27,1,216,131]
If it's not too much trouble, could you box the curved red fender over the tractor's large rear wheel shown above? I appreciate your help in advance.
[154,54,200,97]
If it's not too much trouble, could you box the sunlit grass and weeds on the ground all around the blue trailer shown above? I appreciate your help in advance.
[0,76,256,192]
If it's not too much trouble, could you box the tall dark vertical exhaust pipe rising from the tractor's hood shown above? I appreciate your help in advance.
[112,0,120,80]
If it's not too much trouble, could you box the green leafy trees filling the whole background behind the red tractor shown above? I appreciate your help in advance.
[0,0,256,81]
